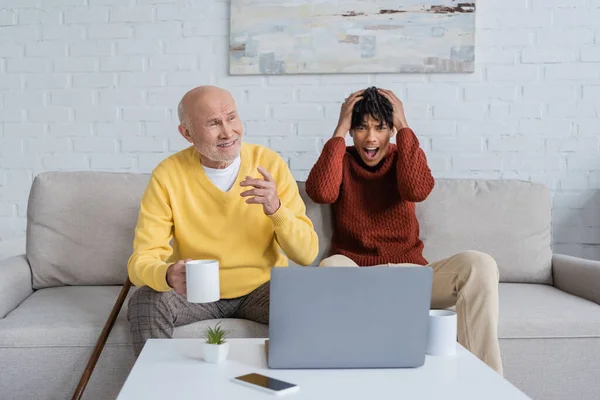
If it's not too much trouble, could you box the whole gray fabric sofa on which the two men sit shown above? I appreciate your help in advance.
[0,172,600,400]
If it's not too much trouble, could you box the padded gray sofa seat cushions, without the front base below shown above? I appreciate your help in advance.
[0,283,600,347]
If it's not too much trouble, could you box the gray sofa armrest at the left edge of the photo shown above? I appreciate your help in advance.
[0,254,33,319]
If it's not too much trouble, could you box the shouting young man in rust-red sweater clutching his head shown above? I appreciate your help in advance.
[306,87,502,374]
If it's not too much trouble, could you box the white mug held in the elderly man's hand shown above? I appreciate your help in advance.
[185,260,221,303]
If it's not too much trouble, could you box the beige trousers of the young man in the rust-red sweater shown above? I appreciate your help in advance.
[320,251,503,375]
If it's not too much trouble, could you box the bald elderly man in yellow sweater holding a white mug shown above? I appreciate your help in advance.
[128,87,318,355]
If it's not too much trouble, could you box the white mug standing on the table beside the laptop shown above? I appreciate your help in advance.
[427,310,457,356]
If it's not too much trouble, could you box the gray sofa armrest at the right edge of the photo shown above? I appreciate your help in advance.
[552,254,600,304]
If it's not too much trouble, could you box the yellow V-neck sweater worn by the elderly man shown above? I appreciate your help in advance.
[127,143,319,298]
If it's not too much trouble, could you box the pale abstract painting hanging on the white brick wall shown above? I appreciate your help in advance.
[229,0,476,75]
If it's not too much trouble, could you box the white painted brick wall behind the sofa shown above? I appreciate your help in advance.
[0,0,600,259]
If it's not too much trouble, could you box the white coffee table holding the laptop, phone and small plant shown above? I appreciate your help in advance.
[118,339,529,400]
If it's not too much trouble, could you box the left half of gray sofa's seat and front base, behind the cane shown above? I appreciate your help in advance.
[0,286,268,400]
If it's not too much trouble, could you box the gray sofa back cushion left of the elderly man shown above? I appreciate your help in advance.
[27,172,149,289]
